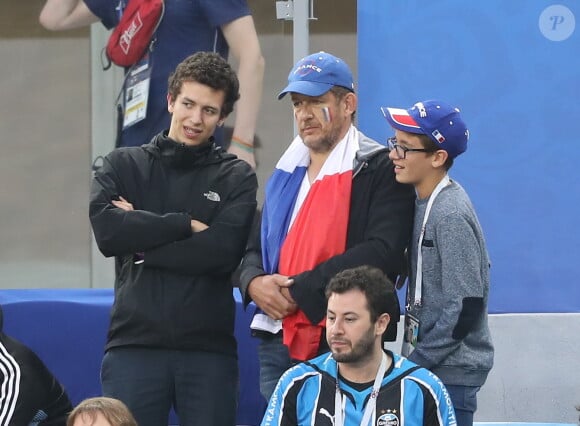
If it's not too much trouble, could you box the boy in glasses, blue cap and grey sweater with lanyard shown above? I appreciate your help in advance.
[382,100,493,426]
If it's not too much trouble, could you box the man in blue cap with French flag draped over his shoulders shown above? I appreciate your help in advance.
[240,52,414,399]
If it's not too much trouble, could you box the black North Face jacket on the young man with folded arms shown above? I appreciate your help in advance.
[89,133,258,356]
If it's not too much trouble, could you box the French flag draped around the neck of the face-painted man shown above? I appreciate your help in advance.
[262,126,359,360]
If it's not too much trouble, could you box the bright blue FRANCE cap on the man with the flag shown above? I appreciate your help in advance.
[278,52,354,99]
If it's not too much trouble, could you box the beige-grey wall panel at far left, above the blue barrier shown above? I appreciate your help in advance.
[0,38,90,288]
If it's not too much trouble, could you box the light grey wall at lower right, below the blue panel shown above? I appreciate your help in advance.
[387,314,580,423]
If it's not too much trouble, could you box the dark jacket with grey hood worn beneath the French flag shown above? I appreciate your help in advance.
[240,132,415,340]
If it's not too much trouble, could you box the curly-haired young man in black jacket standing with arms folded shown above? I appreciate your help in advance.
[90,52,257,426]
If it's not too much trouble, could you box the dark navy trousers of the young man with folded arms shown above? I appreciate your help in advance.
[101,347,238,426]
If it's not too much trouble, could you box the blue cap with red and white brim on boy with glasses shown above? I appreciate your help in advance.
[381,100,469,158]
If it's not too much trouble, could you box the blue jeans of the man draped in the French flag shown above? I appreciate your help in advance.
[258,333,292,401]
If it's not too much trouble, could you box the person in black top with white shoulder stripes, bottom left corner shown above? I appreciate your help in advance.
[0,307,72,426]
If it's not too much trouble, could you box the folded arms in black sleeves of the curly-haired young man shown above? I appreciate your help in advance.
[89,151,257,275]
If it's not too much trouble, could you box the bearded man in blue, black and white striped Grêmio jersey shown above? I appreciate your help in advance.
[262,266,456,426]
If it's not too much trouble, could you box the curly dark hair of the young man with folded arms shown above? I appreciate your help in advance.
[168,52,240,118]
